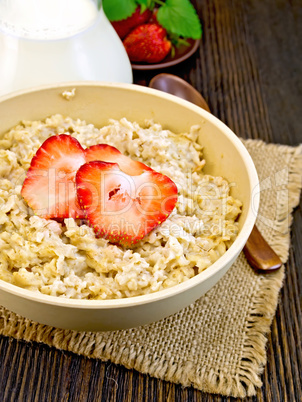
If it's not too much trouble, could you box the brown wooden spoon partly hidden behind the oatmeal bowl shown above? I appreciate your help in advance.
[149,73,282,272]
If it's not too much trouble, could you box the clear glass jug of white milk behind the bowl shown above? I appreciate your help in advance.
[0,0,132,95]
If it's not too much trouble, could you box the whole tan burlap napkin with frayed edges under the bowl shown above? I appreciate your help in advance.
[0,140,302,397]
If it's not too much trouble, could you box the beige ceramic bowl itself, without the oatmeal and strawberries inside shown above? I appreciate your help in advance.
[0,82,259,331]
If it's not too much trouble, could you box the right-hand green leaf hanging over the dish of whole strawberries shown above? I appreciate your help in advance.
[157,0,202,39]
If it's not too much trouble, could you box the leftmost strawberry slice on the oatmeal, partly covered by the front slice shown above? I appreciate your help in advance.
[21,134,86,219]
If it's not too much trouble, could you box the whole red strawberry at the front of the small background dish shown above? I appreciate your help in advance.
[123,24,171,63]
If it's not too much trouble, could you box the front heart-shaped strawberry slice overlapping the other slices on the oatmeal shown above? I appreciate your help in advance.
[76,161,177,247]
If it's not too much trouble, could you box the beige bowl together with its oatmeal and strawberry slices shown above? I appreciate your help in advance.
[0,82,259,331]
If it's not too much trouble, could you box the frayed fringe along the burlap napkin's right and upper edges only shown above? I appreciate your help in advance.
[223,140,302,398]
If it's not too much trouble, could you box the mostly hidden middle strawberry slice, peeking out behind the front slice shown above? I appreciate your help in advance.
[85,144,152,176]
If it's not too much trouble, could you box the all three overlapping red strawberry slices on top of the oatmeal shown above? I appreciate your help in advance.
[21,134,177,246]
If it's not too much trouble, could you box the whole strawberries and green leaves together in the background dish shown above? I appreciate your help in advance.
[103,0,202,63]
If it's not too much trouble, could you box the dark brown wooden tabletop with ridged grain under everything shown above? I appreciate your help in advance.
[0,0,302,402]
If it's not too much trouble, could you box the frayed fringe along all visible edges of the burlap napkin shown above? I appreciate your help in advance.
[0,140,302,398]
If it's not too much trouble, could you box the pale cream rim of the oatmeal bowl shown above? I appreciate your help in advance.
[0,81,260,310]
